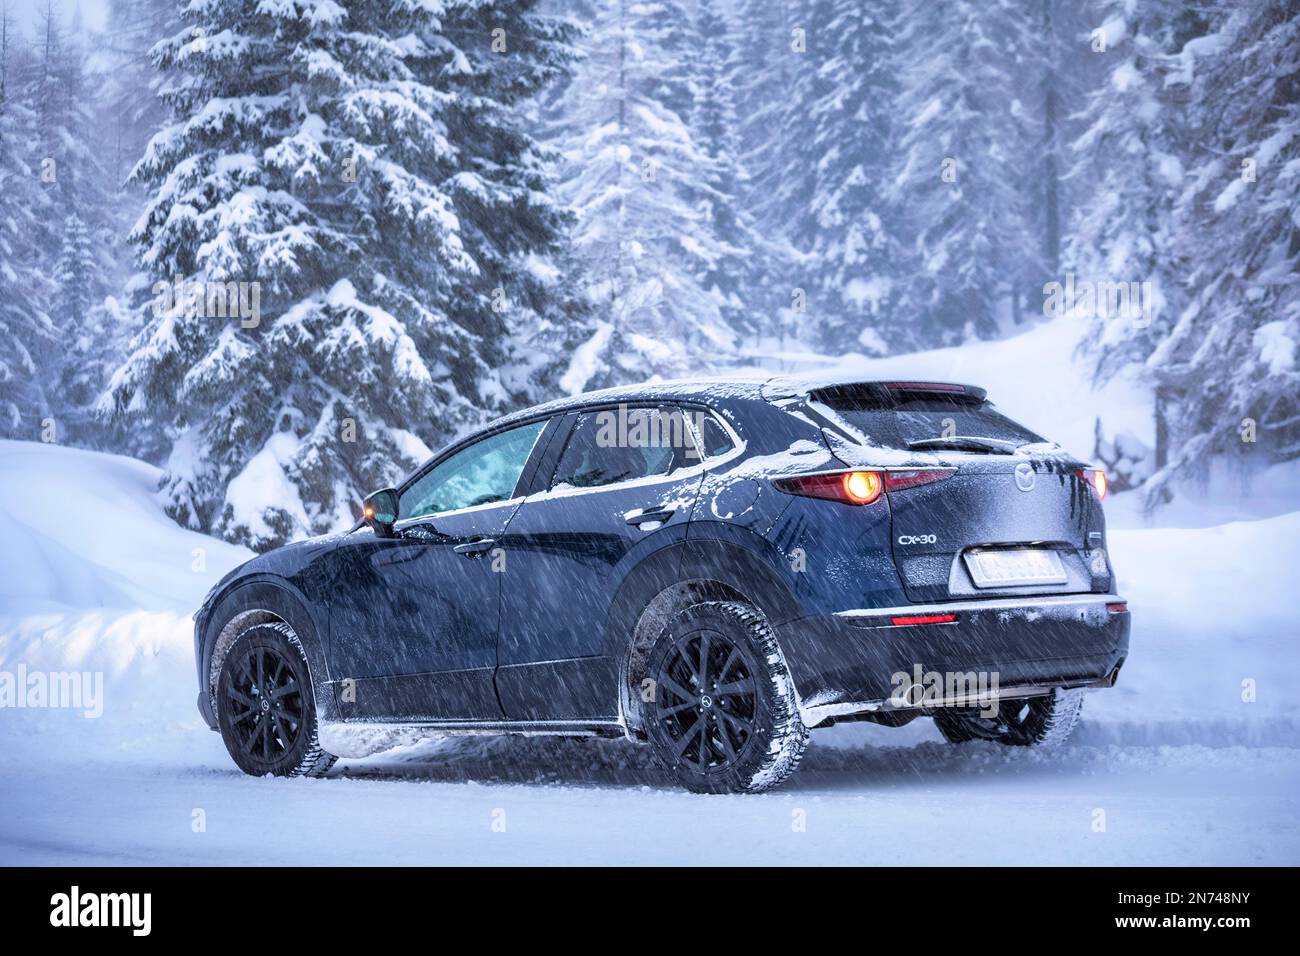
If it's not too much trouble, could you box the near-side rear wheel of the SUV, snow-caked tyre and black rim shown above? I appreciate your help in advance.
[645,601,809,793]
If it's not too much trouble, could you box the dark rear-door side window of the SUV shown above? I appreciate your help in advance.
[550,406,698,488]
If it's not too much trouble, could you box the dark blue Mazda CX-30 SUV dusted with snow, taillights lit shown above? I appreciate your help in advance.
[195,377,1130,792]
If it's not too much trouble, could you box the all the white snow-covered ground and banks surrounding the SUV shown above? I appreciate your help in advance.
[0,324,1300,865]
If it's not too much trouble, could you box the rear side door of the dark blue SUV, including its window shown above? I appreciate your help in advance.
[497,406,702,721]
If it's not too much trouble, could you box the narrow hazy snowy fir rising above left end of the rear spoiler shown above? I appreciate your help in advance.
[803,0,909,354]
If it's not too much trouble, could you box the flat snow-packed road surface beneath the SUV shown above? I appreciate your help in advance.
[0,722,1300,866]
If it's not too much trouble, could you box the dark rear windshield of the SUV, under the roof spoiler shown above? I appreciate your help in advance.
[822,392,1043,450]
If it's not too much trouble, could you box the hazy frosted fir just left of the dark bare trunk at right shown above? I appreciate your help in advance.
[888,0,1039,347]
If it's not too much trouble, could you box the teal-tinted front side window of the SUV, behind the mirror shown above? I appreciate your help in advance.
[398,421,546,519]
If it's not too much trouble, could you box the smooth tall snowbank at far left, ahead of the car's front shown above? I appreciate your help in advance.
[0,441,252,760]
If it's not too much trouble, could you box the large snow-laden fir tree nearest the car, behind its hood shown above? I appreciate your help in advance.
[101,0,582,548]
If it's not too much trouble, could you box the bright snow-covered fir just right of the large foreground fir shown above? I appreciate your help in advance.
[547,0,735,392]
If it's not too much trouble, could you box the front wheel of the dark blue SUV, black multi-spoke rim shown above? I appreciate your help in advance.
[217,622,335,777]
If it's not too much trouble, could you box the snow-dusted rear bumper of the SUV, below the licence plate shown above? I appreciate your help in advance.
[777,594,1130,726]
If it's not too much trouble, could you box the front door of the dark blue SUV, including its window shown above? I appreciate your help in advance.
[330,420,547,721]
